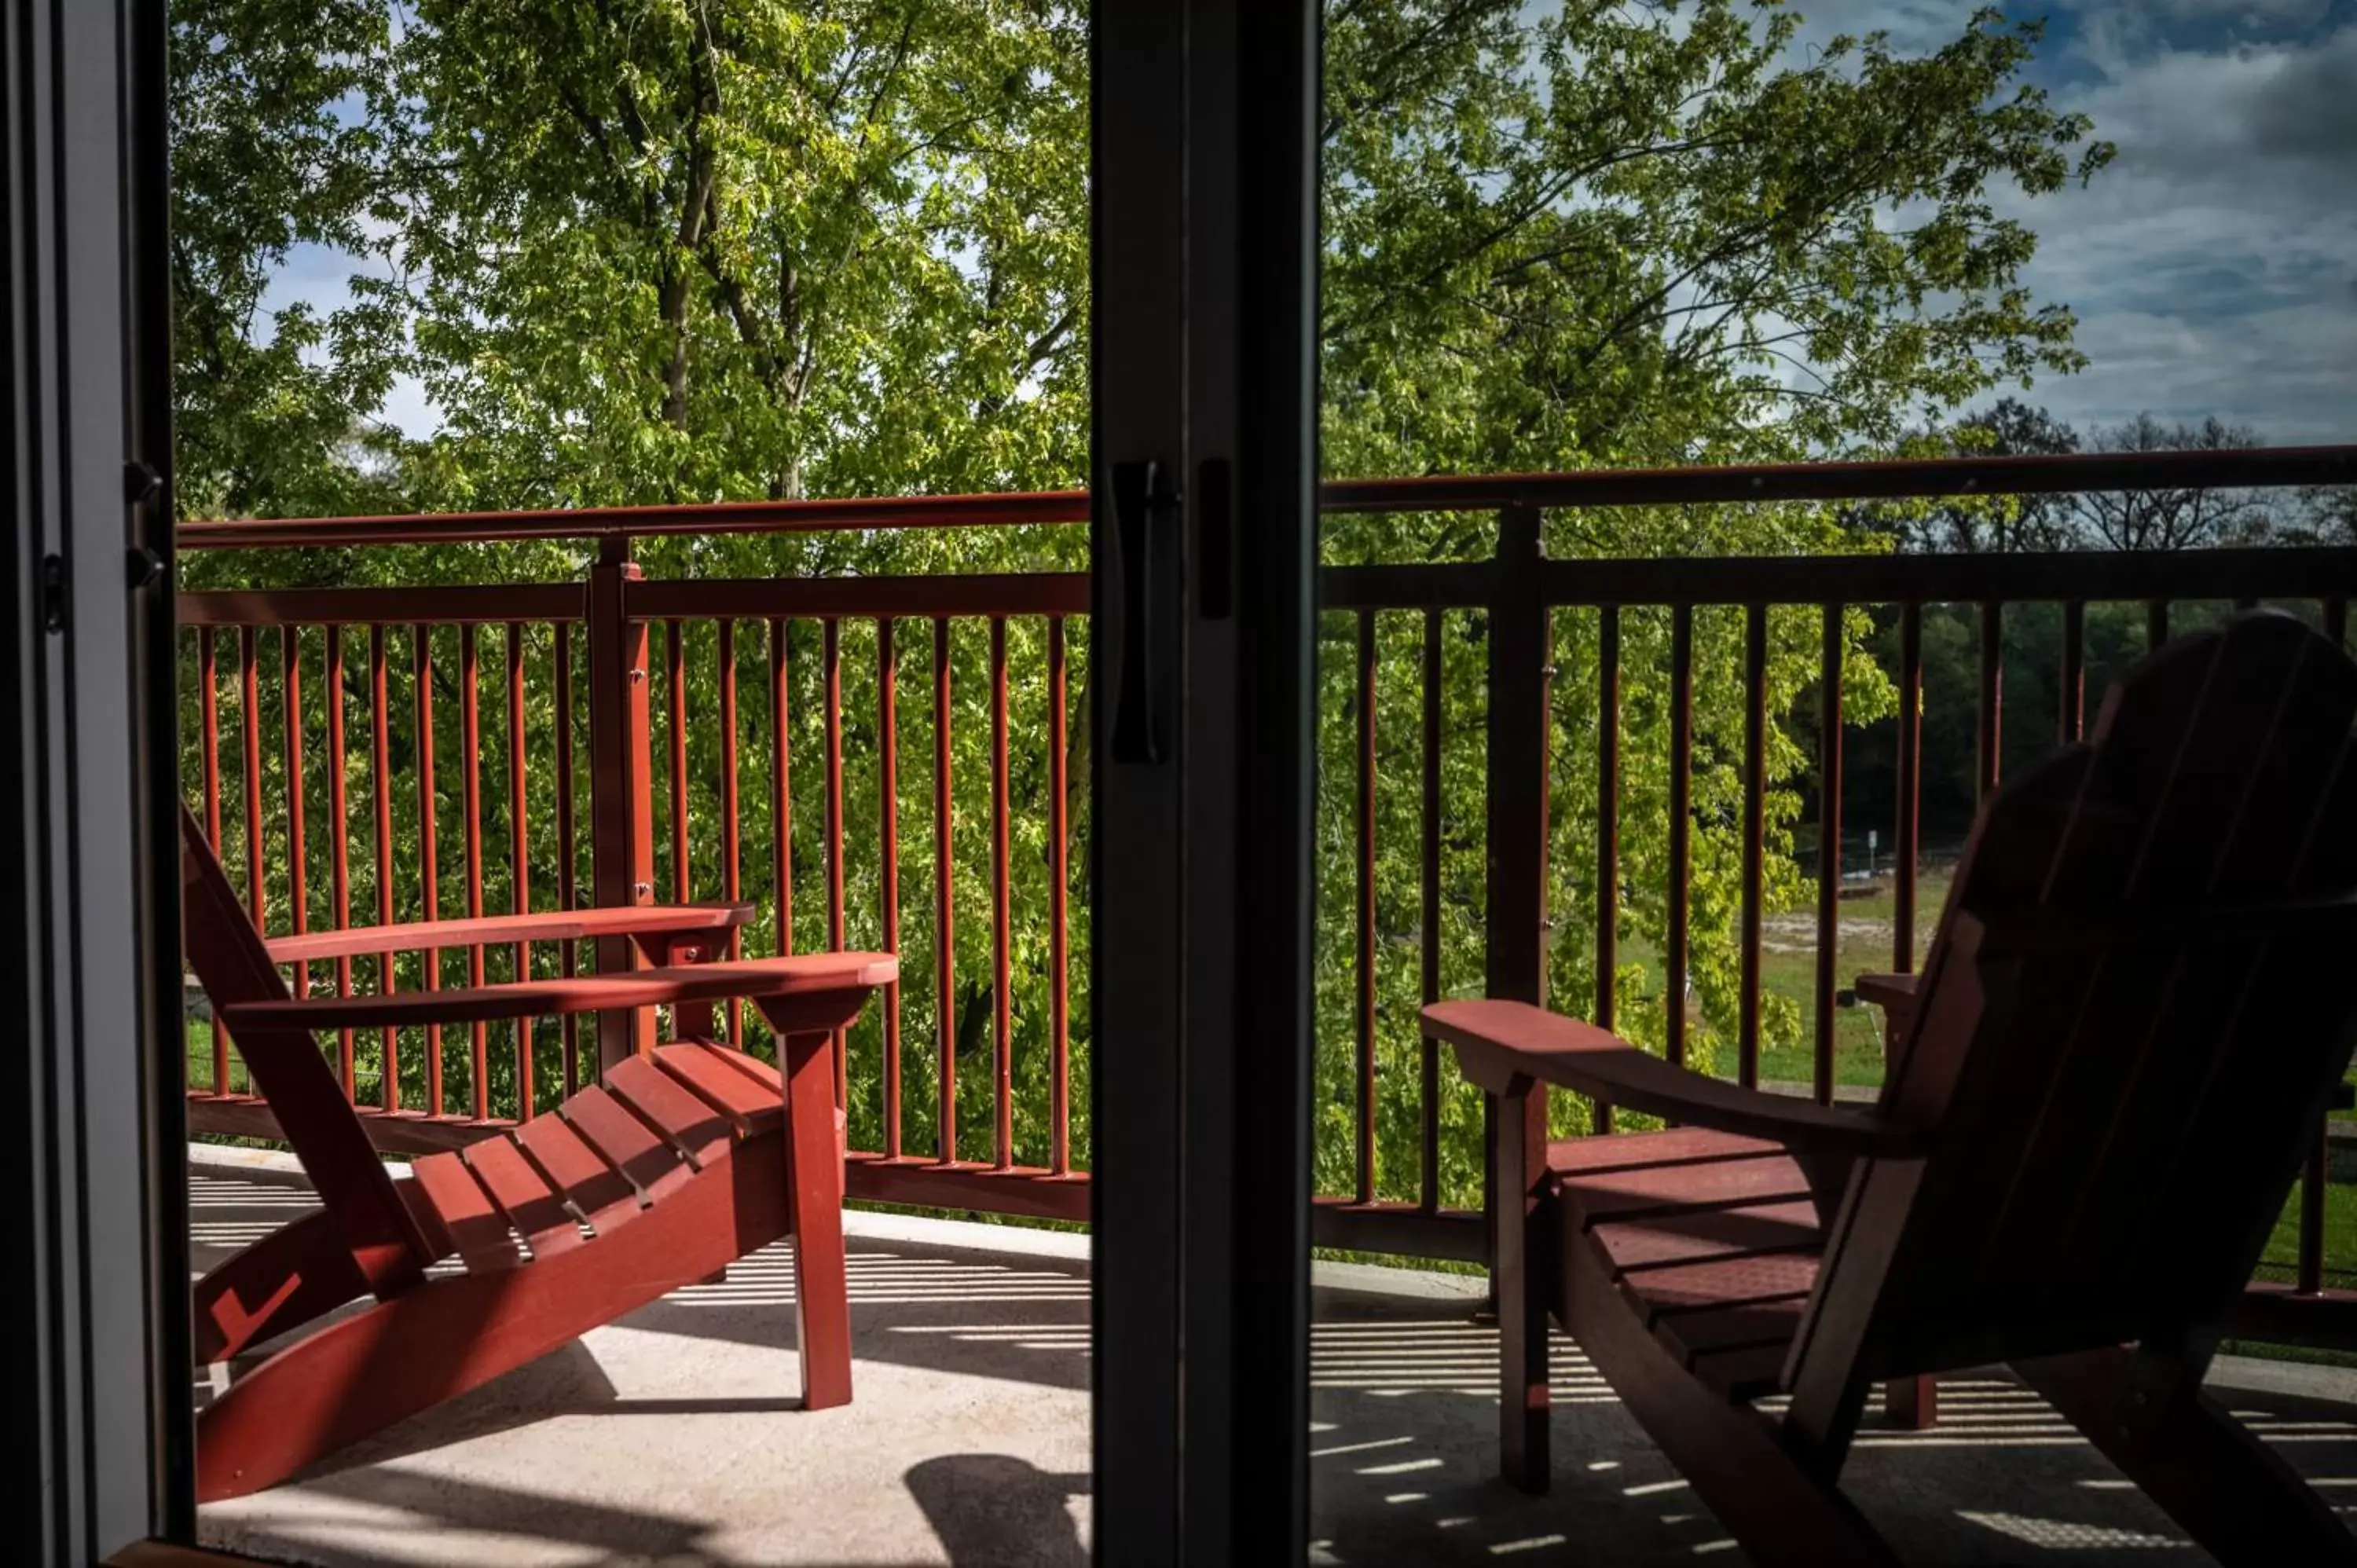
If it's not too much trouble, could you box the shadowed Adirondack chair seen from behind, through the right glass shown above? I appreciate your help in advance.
[1426,613,2357,1563]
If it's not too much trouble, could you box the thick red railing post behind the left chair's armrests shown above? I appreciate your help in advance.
[582,535,655,1071]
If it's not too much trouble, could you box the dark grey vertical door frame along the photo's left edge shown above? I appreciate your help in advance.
[0,0,196,1566]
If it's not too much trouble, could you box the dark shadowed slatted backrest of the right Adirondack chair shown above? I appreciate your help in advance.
[1787,613,2357,1382]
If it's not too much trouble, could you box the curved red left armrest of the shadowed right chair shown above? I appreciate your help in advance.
[1424,1002,1926,1158]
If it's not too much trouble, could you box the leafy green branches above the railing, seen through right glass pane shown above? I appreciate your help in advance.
[1325,0,2112,485]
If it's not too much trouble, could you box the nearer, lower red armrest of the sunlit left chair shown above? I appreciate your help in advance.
[217,953,900,1033]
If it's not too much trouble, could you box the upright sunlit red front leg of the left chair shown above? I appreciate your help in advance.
[780,1033,851,1410]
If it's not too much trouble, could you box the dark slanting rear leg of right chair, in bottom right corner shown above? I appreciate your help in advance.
[2015,1351,2357,1568]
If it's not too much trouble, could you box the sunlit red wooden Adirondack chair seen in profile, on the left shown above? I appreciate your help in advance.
[181,811,898,1502]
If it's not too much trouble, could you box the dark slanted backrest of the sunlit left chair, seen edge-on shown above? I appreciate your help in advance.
[179,807,434,1295]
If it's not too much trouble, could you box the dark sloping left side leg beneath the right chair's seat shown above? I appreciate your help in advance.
[1563,1257,1900,1568]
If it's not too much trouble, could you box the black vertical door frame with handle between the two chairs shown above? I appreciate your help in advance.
[1091,0,1320,1566]
